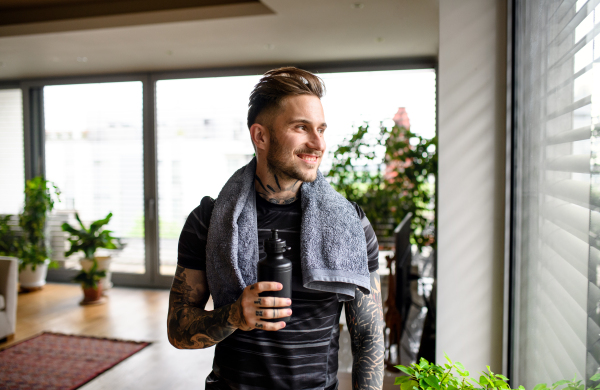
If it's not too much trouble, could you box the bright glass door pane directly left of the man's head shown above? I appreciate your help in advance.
[156,76,260,275]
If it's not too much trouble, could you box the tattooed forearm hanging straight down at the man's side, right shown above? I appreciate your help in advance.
[345,272,384,390]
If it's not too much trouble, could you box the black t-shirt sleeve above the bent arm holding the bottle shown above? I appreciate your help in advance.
[177,196,215,271]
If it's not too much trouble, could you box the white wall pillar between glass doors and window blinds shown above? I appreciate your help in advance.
[436,0,506,376]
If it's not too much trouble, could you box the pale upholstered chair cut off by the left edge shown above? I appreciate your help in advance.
[0,256,19,341]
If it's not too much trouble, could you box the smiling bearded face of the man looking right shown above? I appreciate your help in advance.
[267,95,327,182]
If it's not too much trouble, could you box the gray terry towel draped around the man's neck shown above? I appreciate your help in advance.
[206,158,370,308]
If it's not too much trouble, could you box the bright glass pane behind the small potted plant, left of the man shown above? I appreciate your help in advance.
[44,82,145,273]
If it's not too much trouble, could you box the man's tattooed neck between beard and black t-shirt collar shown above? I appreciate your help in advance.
[254,168,302,204]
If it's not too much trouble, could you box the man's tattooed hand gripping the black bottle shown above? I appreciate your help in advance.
[228,282,292,331]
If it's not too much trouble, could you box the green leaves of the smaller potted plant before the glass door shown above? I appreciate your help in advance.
[62,213,124,290]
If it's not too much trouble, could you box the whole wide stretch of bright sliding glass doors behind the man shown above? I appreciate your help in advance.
[35,69,435,287]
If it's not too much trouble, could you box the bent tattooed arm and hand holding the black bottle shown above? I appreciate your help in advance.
[167,265,291,349]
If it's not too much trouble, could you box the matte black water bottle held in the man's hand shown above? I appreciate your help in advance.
[258,229,292,322]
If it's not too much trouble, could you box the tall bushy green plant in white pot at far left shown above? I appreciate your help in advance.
[15,176,60,291]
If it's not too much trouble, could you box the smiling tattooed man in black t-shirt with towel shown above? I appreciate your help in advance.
[168,68,384,390]
